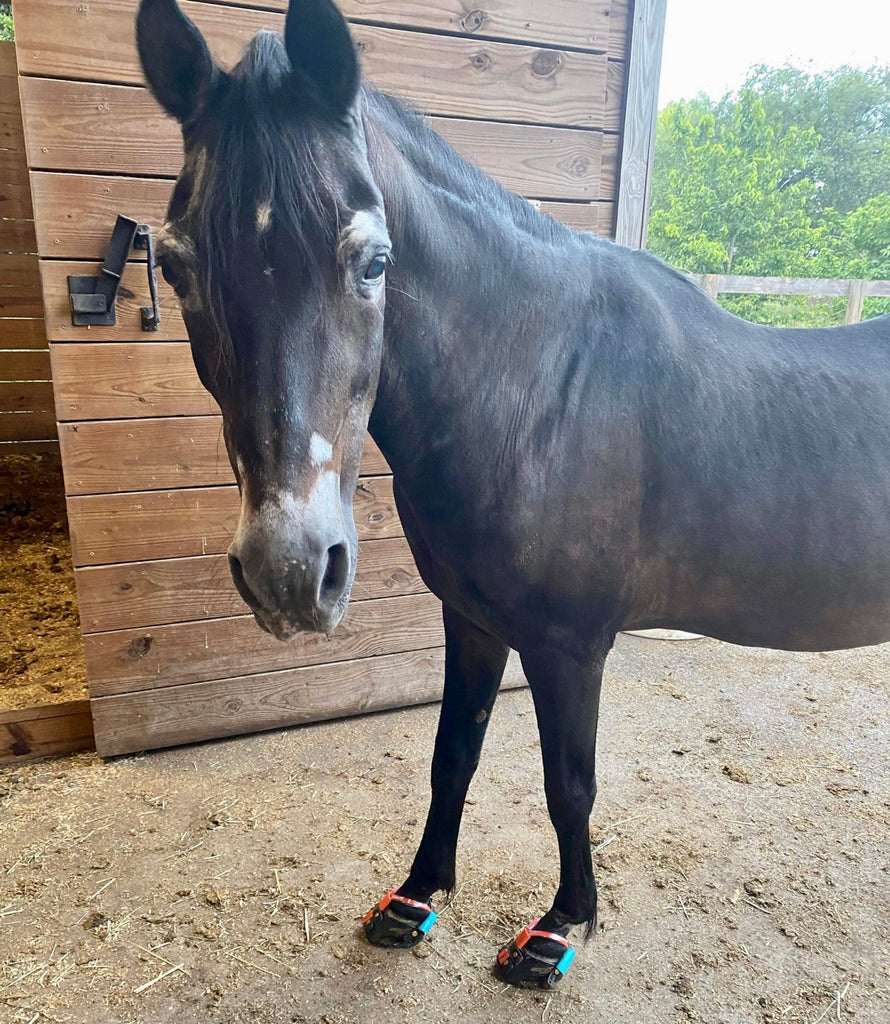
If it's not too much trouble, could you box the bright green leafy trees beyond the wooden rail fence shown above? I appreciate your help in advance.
[649,68,890,325]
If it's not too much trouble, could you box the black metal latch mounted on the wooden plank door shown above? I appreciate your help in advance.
[68,216,161,331]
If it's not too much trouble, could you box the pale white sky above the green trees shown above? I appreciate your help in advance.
[659,0,890,108]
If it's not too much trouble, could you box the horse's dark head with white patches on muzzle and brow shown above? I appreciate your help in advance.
[137,0,390,638]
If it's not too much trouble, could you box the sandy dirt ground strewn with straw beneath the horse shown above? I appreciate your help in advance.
[0,637,890,1024]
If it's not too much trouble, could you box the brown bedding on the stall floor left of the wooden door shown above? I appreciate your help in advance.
[0,454,87,712]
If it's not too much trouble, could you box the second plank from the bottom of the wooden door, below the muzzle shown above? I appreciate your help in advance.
[84,594,444,697]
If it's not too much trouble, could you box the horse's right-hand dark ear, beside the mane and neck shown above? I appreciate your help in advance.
[285,0,362,116]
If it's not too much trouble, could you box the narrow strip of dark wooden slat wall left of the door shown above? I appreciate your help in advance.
[0,42,57,448]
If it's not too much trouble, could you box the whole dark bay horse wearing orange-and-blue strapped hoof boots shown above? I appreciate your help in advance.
[137,0,890,984]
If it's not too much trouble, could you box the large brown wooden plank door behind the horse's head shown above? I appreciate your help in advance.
[8,0,629,754]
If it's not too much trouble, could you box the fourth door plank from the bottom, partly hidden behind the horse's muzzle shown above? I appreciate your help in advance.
[68,476,402,565]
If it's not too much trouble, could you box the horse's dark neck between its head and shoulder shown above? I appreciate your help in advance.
[369,93,582,482]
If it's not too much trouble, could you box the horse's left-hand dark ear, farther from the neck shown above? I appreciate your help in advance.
[136,0,222,122]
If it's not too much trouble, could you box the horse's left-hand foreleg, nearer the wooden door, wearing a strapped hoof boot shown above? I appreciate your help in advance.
[365,605,509,946]
